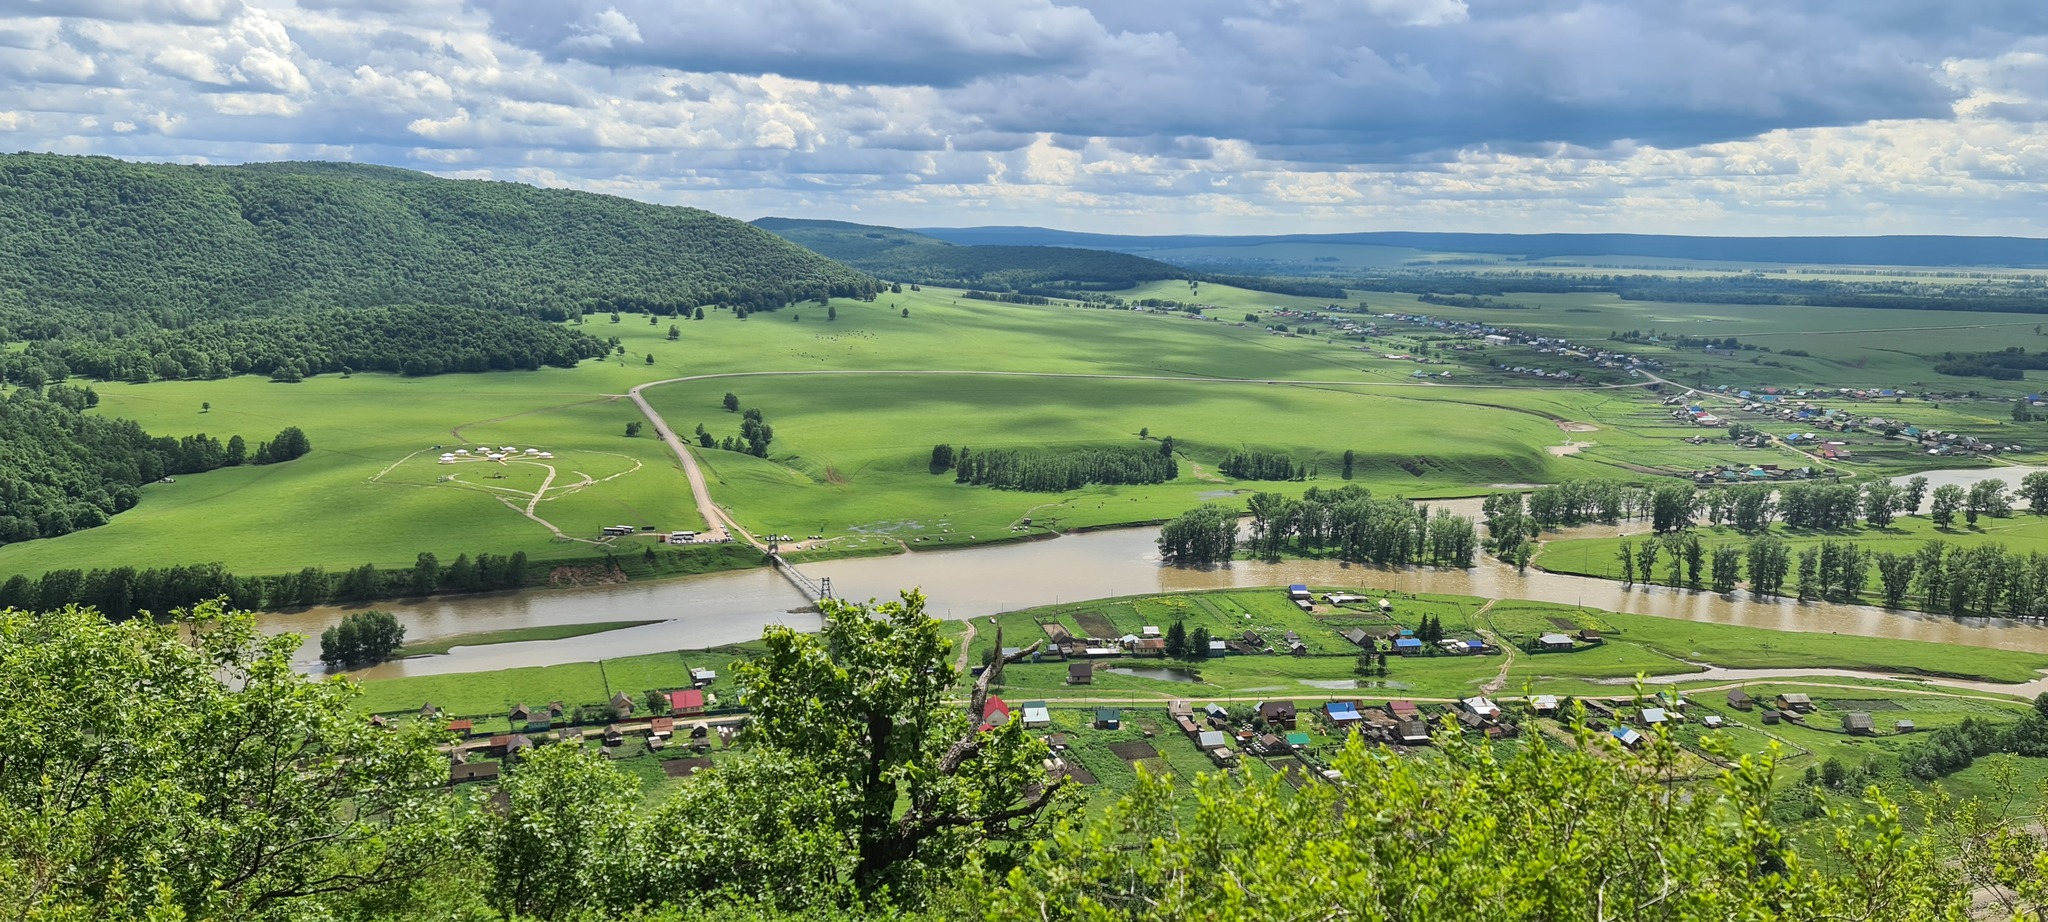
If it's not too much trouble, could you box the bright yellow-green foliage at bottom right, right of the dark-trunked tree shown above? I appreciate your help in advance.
[961,729,1974,922]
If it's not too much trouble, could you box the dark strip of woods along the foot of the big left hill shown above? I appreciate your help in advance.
[0,305,612,387]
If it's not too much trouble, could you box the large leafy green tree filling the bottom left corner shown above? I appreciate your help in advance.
[0,602,449,920]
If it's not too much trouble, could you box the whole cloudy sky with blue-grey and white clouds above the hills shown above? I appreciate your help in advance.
[0,0,2048,236]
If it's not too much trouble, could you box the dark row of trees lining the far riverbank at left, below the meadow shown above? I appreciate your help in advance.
[0,551,526,621]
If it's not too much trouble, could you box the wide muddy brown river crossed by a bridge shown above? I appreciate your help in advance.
[280,489,2048,678]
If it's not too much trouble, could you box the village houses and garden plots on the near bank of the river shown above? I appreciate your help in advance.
[391,584,1941,797]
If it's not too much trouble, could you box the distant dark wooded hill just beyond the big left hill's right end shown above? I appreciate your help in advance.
[754,217,1190,291]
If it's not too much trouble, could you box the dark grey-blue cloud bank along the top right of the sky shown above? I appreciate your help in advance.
[473,0,2048,158]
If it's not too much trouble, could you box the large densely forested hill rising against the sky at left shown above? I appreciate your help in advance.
[0,154,872,321]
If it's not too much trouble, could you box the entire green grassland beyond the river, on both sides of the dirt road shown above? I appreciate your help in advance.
[24,274,2048,574]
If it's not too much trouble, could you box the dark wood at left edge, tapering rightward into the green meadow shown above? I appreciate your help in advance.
[0,385,311,545]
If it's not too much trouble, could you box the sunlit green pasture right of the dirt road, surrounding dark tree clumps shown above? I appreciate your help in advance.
[649,375,1567,543]
